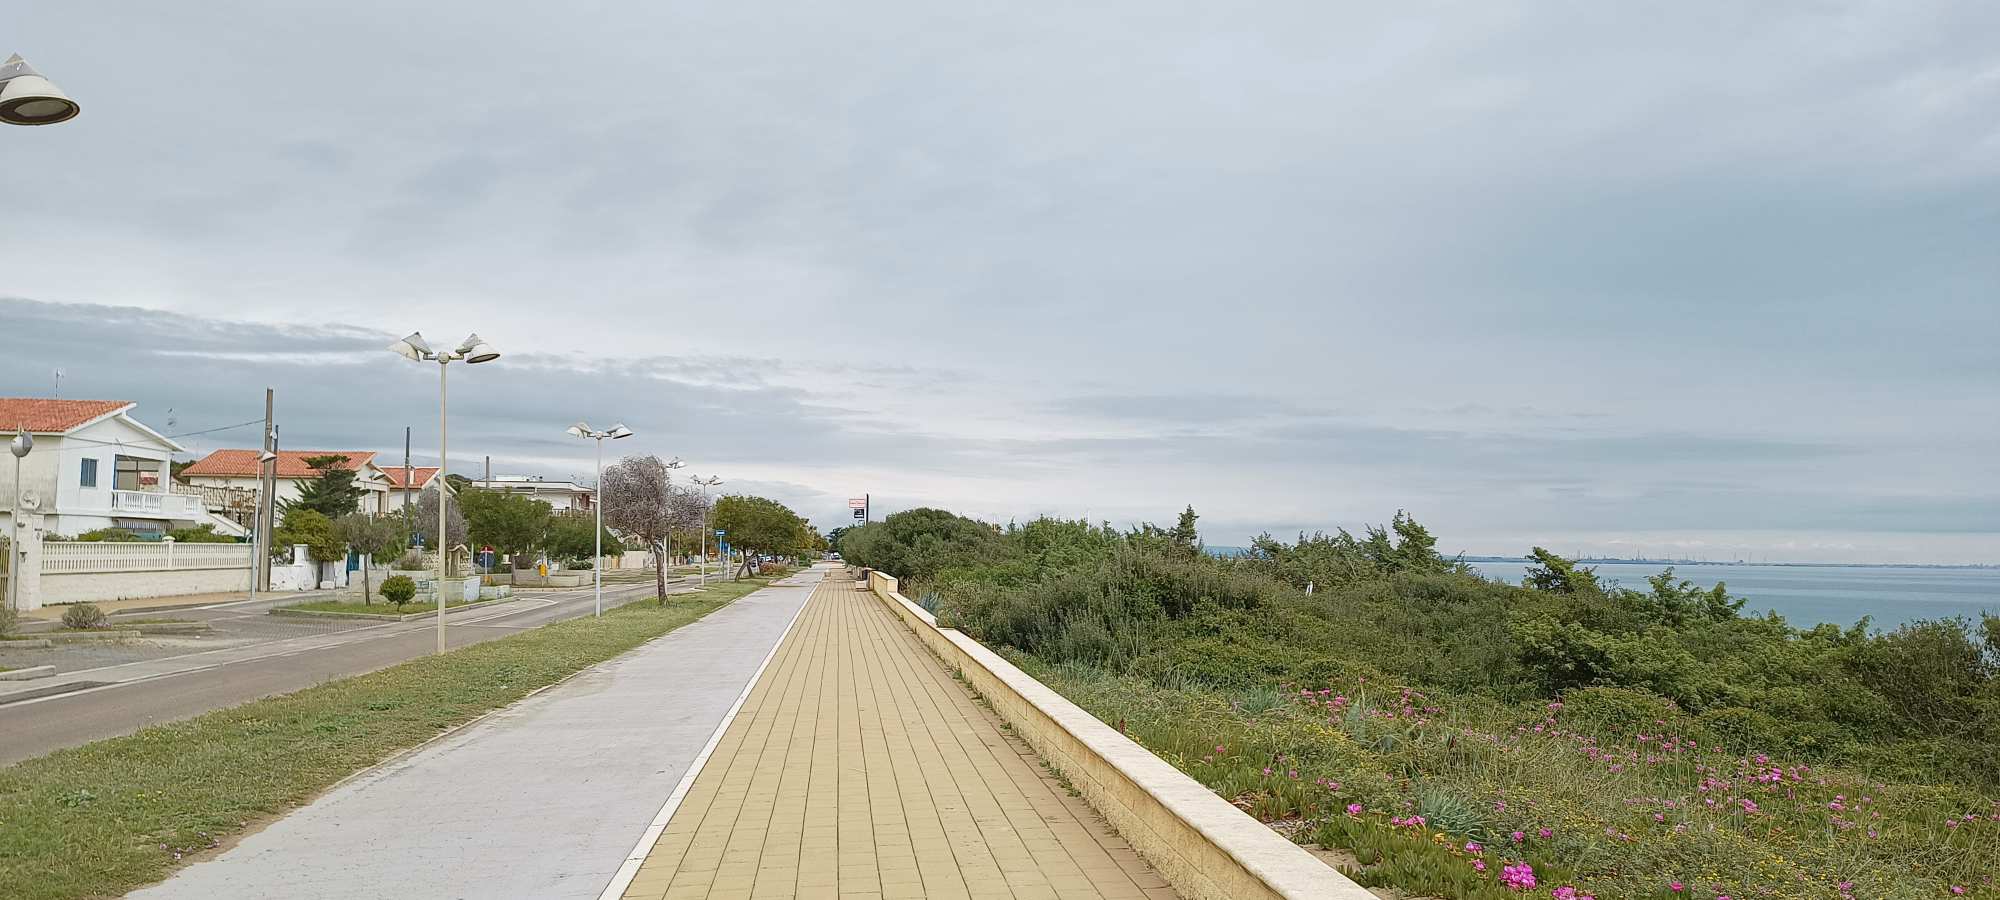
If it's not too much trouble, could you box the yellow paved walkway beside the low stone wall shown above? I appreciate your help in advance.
[624,576,1174,900]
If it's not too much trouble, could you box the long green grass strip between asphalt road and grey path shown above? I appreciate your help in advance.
[0,580,768,900]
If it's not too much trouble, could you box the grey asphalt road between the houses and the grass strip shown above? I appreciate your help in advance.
[0,580,704,766]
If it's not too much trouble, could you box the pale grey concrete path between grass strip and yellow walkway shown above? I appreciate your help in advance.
[128,570,824,900]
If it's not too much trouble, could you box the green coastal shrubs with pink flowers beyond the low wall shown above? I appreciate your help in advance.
[838,510,2000,900]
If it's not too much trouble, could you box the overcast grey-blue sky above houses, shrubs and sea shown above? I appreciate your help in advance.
[0,0,2000,562]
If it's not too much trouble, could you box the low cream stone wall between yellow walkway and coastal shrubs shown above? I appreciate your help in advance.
[868,572,1374,900]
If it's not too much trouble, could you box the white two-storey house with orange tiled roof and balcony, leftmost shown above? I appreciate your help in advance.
[0,398,242,534]
